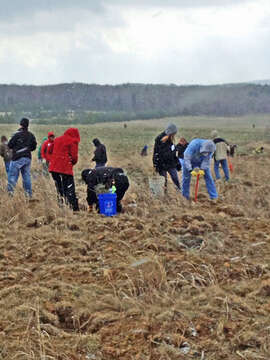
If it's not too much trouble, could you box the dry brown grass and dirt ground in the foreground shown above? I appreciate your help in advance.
[0,122,270,360]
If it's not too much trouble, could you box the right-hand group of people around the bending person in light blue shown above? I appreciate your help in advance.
[153,124,235,200]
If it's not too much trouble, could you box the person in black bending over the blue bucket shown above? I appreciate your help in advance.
[82,167,129,212]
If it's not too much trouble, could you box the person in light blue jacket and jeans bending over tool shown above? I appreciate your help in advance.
[182,139,218,199]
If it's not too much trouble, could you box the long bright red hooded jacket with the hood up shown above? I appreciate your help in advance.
[49,128,80,175]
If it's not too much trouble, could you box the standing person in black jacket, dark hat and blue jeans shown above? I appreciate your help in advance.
[8,118,37,197]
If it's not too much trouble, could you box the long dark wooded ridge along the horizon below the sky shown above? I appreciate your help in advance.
[0,83,270,122]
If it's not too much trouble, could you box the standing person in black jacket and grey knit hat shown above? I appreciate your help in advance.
[153,124,181,191]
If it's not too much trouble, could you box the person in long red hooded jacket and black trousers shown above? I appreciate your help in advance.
[49,128,80,211]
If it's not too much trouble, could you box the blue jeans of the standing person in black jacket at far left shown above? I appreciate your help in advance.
[7,157,32,197]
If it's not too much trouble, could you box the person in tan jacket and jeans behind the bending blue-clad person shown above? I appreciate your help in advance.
[211,130,230,181]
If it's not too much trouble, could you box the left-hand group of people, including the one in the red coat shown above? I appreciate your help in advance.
[0,118,129,212]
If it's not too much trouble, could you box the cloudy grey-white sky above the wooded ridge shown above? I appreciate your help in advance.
[0,0,270,85]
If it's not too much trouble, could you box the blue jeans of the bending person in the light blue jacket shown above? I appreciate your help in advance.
[182,164,218,199]
